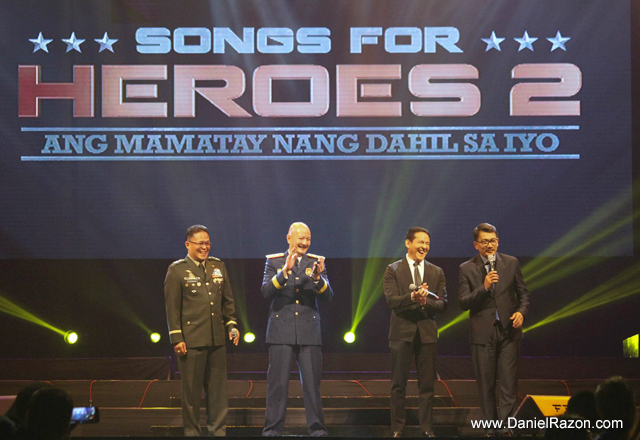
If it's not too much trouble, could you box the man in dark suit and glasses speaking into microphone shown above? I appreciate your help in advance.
[458,223,529,436]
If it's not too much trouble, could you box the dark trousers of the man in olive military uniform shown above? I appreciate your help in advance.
[178,346,229,437]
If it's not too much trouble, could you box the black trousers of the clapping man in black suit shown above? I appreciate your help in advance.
[389,331,438,432]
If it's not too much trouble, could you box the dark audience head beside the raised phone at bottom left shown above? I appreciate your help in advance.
[23,388,73,440]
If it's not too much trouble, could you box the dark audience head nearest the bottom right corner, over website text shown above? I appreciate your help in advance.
[596,376,636,440]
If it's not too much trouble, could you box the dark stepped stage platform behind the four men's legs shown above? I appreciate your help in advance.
[0,353,640,437]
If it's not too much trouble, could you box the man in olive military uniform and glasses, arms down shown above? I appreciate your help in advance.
[164,225,240,436]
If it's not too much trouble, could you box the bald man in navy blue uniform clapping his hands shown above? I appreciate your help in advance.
[261,223,333,437]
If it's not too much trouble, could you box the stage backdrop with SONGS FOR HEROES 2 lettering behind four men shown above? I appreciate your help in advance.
[0,0,640,356]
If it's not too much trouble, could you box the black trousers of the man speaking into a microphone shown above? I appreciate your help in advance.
[471,321,520,434]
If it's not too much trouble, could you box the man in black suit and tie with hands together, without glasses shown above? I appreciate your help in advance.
[384,227,447,437]
